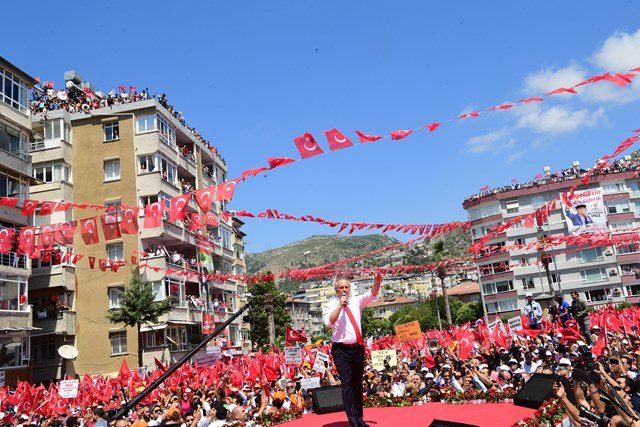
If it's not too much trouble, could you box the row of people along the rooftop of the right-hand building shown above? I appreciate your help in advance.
[463,156,640,203]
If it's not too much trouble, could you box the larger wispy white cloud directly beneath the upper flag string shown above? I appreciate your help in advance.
[516,104,605,133]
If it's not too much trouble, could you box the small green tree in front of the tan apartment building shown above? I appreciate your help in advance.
[107,275,171,367]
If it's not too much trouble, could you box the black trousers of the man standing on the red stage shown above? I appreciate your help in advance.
[331,343,364,427]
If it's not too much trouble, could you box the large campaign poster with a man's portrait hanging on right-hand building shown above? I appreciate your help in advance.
[560,188,607,235]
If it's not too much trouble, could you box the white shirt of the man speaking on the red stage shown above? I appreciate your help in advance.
[322,291,377,344]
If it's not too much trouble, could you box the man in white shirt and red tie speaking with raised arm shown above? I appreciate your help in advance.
[322,272,382,427]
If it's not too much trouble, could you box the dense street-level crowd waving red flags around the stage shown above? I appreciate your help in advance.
[0,301,640,427]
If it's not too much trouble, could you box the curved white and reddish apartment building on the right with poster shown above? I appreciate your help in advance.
[463,171,640,315]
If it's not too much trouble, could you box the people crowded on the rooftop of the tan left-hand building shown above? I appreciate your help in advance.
[30,81,226,164]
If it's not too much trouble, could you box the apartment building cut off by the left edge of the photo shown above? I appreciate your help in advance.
[0,57,36,385]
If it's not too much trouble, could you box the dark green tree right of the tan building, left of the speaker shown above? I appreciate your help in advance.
[245,281,291,349]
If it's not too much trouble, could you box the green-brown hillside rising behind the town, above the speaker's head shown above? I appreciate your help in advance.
[245,234,400,273]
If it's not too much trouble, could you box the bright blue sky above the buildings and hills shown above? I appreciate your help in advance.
[7,0,640,252]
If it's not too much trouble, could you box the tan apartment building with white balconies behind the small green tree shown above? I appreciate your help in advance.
[31,72,247,380]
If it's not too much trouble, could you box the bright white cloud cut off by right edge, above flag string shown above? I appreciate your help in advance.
[591,30,640,72]
